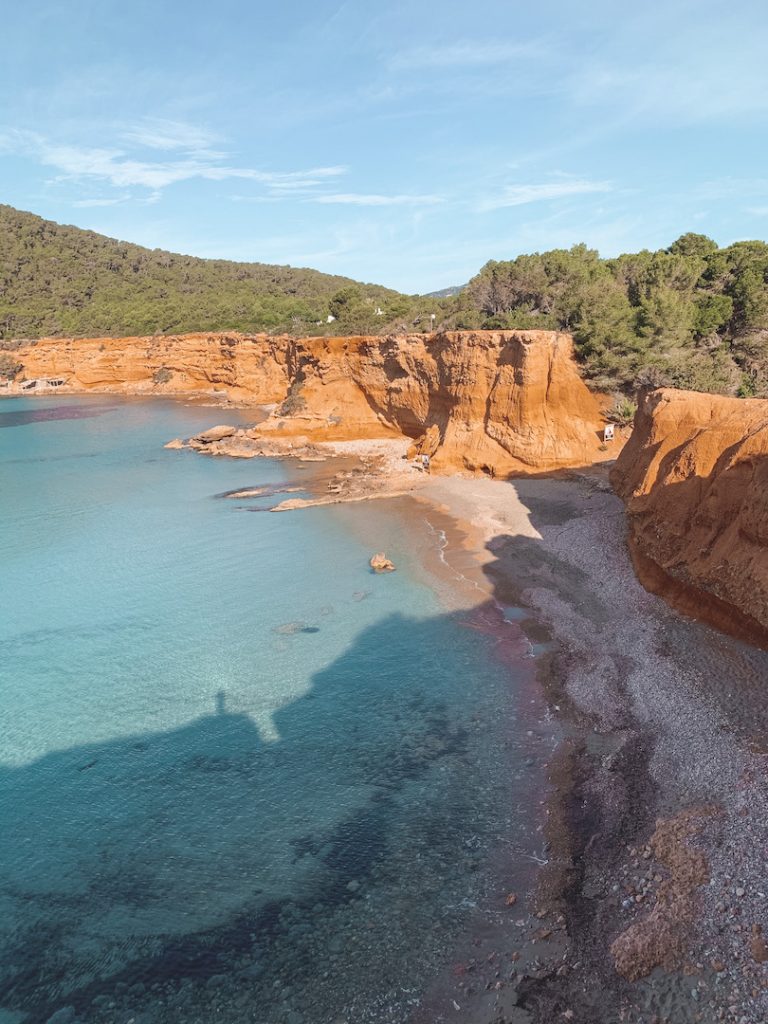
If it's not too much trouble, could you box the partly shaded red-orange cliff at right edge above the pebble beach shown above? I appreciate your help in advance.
[611,389,768,644]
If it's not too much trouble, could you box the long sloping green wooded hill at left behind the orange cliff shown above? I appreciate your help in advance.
[0,206,409,338]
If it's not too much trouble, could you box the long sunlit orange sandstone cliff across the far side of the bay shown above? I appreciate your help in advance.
[4,331,610,476]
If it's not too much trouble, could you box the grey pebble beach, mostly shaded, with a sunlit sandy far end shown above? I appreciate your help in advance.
[422,472,768,1024]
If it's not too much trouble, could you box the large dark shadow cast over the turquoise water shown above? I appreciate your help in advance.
[0,581,540,1024]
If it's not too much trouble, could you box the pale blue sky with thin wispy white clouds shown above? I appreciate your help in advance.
[0,0,768,292]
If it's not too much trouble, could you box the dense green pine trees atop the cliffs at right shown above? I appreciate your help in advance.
[450,233,768,396]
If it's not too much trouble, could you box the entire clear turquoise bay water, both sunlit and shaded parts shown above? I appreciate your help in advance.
[0,397,536,1024]
